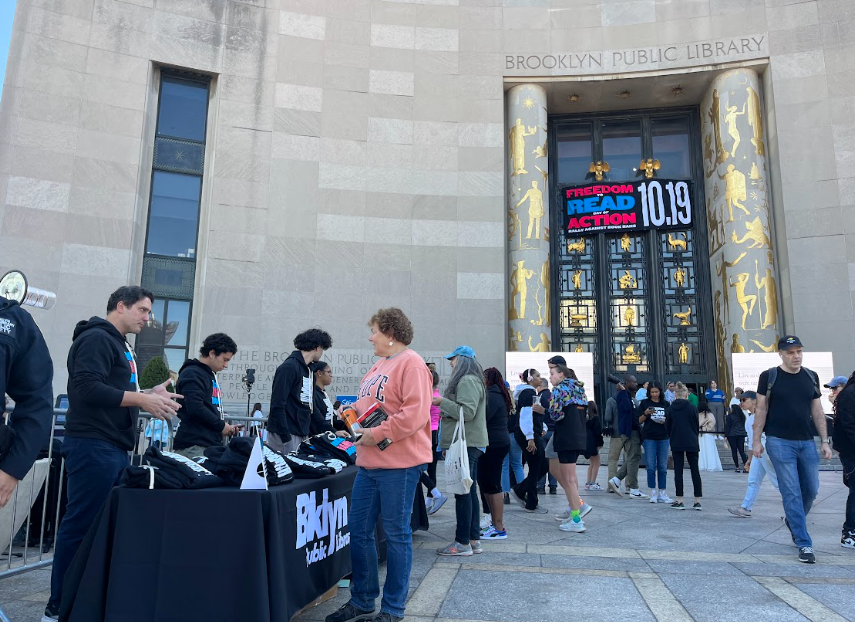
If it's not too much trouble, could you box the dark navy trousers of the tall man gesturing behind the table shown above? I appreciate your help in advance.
[49,436,130,607]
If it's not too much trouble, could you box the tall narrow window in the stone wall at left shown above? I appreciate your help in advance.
[137,71,210,372]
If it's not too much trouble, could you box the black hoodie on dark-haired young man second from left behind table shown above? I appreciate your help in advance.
[173,359,226,449]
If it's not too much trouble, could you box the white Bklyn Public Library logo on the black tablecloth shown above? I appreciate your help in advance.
[295,488,350,567]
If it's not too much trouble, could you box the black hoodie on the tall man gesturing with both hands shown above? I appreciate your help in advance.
[65,317,139,451]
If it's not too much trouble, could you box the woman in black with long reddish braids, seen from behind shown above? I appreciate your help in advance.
[478,367,511,540]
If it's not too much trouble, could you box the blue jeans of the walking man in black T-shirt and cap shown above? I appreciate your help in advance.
[766,436,819,548]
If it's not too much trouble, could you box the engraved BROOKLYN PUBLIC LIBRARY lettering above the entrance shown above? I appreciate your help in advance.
[505,36,765,70]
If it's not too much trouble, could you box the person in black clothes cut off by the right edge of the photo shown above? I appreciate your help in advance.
[826,372,855,549]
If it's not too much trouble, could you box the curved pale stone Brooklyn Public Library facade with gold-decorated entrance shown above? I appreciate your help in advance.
[0,0,855,410]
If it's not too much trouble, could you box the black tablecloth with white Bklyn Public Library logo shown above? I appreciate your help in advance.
[60,467,356,622]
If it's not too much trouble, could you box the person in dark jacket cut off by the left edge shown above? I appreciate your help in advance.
[0,296,53,508]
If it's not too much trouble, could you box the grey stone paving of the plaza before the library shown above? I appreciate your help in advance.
[0,465,855,622]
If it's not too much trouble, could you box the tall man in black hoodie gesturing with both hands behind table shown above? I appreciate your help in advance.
[44,286,182,620]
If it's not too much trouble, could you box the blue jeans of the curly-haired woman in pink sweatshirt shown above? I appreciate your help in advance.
[348,465,425,618]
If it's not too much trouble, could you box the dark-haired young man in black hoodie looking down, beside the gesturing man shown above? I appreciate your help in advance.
[172,333,239,458]
